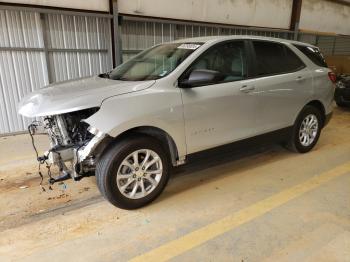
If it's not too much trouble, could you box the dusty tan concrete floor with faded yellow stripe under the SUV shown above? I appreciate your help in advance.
[0,105,350,262]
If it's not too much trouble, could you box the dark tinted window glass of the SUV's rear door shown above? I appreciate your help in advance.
[253,41,304,76]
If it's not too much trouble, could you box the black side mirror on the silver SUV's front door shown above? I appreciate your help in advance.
[179,69,224,88]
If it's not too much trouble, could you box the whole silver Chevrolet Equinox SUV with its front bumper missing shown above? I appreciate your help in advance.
[19,36,335,209]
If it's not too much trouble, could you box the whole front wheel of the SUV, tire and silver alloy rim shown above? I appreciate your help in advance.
[96,136,170,209]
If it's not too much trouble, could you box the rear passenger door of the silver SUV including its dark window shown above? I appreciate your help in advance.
[251,40,312,134]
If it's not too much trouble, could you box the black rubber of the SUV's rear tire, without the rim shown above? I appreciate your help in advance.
[287,105,324,153]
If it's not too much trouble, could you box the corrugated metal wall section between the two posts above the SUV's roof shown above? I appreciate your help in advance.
[121,16,294,61]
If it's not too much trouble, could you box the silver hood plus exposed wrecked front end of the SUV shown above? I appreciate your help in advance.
[18,76,155,187]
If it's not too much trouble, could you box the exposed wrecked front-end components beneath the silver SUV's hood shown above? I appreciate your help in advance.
[28,107,108,184]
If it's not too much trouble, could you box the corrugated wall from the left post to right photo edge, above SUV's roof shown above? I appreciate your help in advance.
[121,16,350,61]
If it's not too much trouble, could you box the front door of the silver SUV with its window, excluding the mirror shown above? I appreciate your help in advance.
[179,41,255,154]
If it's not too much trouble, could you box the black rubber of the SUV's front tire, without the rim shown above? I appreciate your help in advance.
[96,136,170,209]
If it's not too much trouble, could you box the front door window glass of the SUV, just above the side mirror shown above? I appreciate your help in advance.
[185,41,247,83]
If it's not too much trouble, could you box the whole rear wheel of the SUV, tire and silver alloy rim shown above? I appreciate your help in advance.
[287,105,323,153]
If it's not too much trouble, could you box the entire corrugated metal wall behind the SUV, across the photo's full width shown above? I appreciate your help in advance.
[0,2,350,135]
